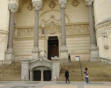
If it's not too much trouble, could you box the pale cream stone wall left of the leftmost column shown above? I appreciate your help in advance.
[0,0,9,60]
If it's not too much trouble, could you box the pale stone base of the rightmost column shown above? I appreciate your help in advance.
[90,47,99,61]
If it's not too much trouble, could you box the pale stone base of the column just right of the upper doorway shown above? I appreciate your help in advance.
[60,46,68,61]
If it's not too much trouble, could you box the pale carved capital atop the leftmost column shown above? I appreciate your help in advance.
[8,0,19,12]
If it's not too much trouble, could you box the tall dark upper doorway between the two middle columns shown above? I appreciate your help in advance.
[48,36,59,60]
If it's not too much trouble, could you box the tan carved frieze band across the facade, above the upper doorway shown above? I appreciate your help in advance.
[14,23,89,39]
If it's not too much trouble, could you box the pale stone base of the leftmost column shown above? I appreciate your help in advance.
[5,49,14,64]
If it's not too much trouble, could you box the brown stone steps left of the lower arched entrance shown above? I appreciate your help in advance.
[0,62,21,81]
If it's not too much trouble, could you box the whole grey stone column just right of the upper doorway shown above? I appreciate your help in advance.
[59,0,68,59]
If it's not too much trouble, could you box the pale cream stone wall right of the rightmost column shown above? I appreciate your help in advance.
[94,0,111,59]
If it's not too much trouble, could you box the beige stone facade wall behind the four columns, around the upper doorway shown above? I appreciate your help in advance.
[14,0,90,60]
